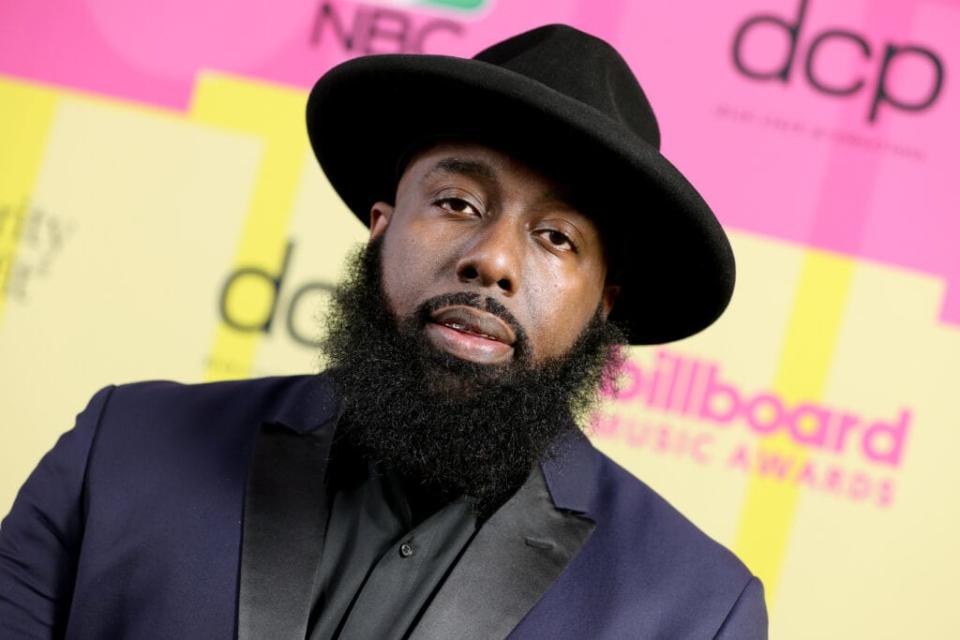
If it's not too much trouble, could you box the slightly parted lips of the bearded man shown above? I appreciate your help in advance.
[427,305,516,364]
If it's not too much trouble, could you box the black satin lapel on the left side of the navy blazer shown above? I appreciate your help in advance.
[237,424,333,640]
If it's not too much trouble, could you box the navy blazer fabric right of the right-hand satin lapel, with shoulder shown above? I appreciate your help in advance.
[517,449,765,638]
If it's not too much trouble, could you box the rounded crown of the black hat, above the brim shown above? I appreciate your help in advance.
[474,24,660,149]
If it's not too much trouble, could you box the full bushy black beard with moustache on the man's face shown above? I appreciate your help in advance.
[321,241,626,517]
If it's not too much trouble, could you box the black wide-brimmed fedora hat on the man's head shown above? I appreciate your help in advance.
[307,25,734,344]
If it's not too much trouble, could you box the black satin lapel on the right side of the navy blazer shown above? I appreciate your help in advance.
[411,466,595,640]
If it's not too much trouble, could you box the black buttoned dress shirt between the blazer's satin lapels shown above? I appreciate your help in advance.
[308,447,477,640]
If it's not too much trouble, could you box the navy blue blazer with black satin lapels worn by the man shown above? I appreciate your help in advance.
[0,375,767,640]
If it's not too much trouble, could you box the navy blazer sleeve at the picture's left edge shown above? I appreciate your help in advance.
[0,387,113,640]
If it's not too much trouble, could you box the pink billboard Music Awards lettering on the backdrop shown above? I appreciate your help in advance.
[591,350,913,506]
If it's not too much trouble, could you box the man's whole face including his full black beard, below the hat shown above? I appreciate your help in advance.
[321,143,625,510]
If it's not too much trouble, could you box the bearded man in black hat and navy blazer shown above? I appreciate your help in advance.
[0,25,766,639]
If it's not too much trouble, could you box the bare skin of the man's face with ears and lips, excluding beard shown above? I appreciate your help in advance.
[370,142,618,365]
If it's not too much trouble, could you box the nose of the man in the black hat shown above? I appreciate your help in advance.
[457,218,523,295]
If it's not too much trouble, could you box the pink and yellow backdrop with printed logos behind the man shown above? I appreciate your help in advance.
[0,0,960,639]
